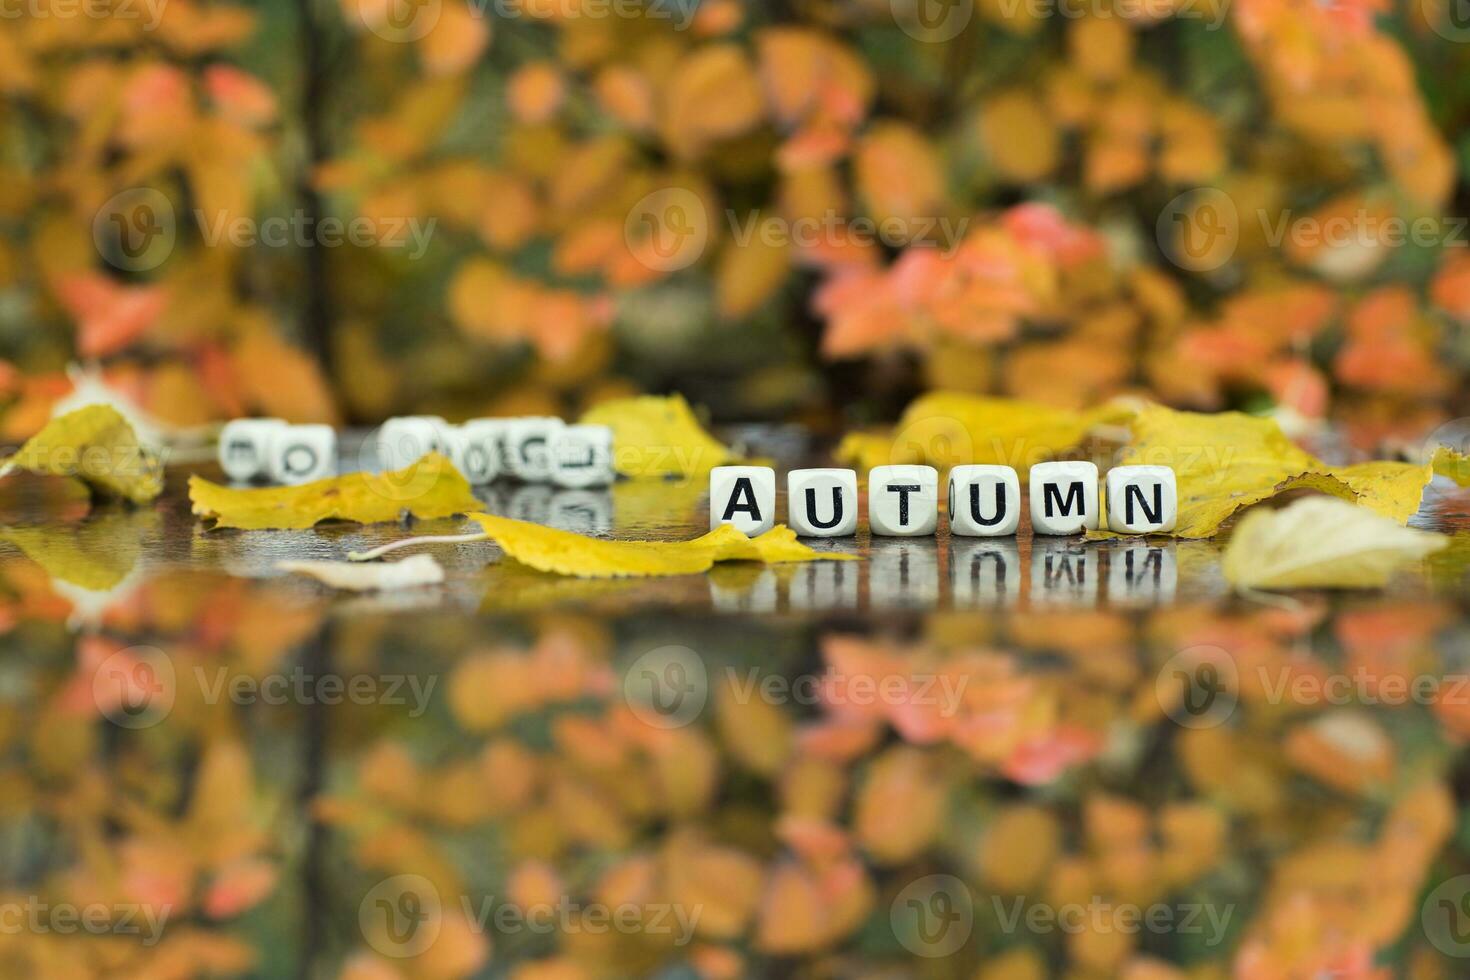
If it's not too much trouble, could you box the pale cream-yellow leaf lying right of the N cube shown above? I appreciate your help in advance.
[1223,497,1449,589]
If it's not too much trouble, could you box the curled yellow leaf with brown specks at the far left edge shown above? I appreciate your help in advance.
[0,404,163,504]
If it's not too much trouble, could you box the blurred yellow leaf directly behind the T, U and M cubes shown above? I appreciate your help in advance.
[836,391,1129,476]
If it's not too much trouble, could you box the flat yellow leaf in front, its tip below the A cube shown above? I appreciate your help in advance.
[470,514,853,579]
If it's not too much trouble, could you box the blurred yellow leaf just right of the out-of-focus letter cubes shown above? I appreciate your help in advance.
[582,395,736,476]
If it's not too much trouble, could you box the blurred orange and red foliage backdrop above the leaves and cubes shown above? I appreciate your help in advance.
[0,0,1470,450]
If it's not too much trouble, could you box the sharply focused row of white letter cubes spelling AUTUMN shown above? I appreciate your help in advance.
[710,461,1179,538]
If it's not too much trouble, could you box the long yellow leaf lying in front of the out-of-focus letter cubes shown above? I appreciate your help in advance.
[188,453,481,530]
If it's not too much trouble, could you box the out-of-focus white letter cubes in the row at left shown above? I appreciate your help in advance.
[219,416,613,489]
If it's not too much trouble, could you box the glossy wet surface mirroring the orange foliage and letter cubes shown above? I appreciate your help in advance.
[0,432,1470,980]
